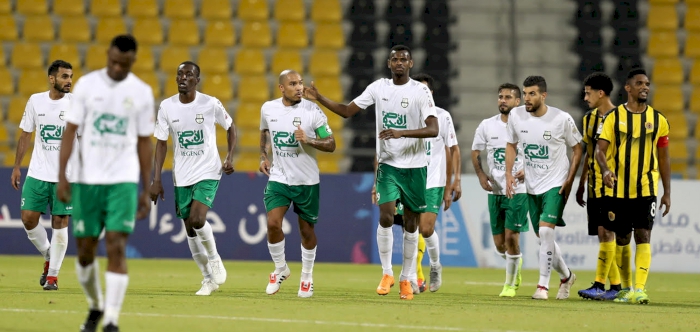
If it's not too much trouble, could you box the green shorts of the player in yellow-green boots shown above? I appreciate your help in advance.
[489,194,530,235]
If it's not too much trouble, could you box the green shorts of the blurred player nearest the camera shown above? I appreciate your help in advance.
[72,182,139,238]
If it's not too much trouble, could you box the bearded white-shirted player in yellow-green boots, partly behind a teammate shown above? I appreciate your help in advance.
[472,83,530,297]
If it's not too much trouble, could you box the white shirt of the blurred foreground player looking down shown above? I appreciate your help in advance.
[66,68,155,184]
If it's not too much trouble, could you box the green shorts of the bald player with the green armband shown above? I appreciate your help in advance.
[263,181,320,224]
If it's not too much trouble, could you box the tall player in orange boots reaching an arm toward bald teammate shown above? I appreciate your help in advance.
[304,45,439,300]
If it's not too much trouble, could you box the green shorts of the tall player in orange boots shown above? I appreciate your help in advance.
[376,164,428,213]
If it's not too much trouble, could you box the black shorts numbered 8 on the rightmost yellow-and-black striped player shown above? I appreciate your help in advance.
[603,196,658,237]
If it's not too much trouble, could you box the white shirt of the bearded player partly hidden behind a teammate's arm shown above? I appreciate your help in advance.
[472,111,525,195]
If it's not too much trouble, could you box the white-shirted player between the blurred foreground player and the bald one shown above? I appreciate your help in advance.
[150,61,236,296]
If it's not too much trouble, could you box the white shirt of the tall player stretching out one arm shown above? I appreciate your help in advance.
[353,78,437,168]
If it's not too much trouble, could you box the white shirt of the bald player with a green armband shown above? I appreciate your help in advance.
[260,98,332,186]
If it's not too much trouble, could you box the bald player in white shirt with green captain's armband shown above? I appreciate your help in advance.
[260,70,335,297]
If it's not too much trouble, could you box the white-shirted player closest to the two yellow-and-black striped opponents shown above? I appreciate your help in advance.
[506,76,583,300]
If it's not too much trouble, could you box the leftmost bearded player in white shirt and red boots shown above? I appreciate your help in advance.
[10,60,73,290]
